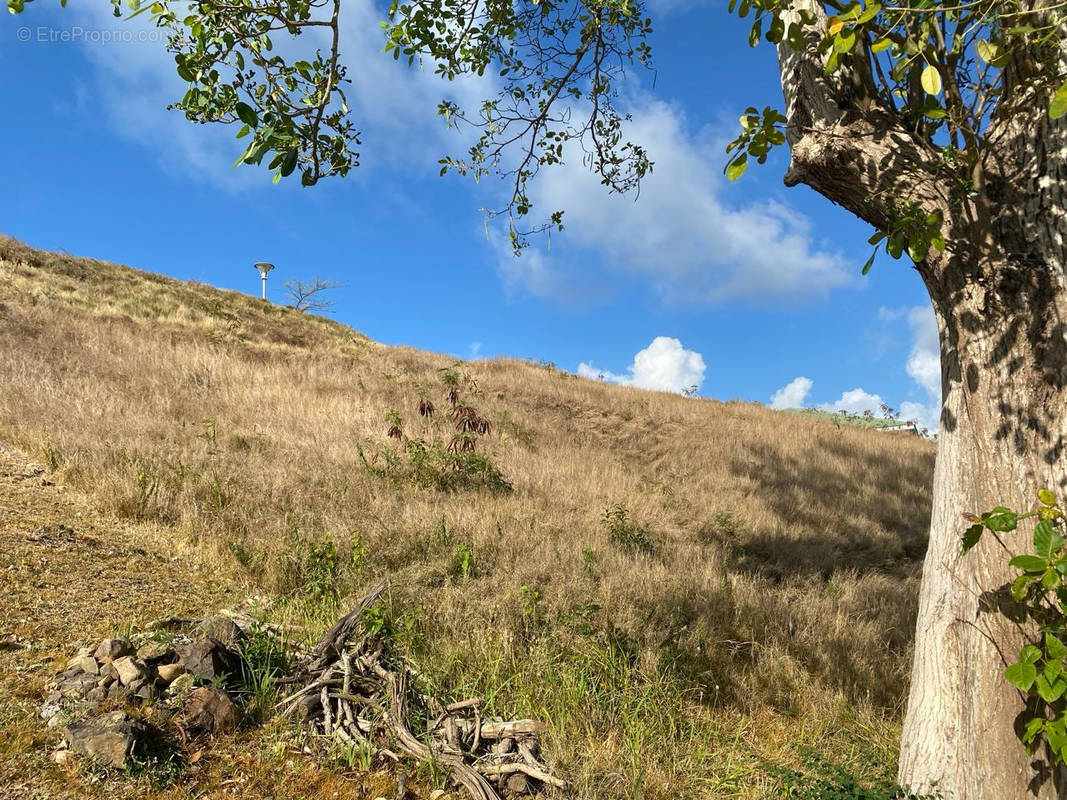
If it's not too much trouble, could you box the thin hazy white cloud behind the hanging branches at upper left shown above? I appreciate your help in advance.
[52,0,495,189]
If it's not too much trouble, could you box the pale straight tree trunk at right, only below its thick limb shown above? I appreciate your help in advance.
[899,260,1067,800]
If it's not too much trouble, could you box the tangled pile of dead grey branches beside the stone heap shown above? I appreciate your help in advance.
[278,581,564,800]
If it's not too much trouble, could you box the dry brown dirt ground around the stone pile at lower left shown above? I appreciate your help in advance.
[0,444,403,800]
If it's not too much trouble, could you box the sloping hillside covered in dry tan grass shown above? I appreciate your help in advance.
[0,234,934,800]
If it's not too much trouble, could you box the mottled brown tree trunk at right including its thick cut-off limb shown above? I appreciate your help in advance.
[779,0,1067,800]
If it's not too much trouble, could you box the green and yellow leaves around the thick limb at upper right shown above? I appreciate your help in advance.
[726,0,1067,273]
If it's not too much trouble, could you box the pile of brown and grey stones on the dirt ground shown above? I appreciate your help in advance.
[41,615,244,768]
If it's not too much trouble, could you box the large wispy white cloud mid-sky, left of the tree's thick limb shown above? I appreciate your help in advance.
[506,97,855,304]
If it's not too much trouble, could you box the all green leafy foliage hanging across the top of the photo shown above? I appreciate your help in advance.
[7,0,1067,254]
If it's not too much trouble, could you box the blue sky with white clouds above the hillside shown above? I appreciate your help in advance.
[0,0,939,433]
